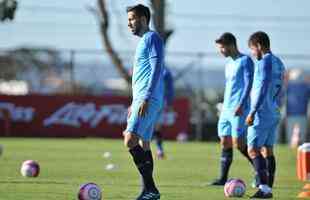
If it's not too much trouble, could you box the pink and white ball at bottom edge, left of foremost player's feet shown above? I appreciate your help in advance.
[78,183,102,200]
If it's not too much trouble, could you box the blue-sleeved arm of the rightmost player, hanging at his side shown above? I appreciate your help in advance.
[246,58,272,125]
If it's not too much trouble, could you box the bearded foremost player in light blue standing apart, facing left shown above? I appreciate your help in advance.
[123,4,164,200]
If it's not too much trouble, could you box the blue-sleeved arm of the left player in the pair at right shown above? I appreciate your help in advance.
[235,58,254,115]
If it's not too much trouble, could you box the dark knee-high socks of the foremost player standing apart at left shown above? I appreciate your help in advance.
[129,145,158,192]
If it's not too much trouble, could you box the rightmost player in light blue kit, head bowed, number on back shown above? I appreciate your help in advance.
[246,31,285,199]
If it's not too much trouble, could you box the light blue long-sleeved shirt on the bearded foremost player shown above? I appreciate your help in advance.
[132,31,164,104]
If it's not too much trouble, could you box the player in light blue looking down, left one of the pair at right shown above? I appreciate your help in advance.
[211,33,254,185]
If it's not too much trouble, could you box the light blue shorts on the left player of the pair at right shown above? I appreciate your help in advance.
[217,112,247,138]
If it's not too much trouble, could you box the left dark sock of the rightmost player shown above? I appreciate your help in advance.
[252,155,268,185]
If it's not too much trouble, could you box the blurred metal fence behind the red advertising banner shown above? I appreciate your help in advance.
[0,48,310,140]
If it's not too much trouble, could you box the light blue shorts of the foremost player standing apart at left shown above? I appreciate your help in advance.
[125,100,162,141]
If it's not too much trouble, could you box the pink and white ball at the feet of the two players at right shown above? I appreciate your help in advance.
[224,179,246,197]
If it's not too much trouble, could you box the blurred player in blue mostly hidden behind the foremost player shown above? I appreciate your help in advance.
[154,67,174,159]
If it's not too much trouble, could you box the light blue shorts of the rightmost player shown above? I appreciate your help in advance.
[247,115,280,148]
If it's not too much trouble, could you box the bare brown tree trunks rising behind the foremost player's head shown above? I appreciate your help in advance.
[89,0,173,89]
